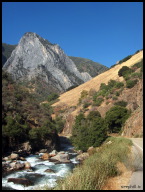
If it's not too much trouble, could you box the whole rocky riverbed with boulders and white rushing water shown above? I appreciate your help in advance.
[2,138,84,190]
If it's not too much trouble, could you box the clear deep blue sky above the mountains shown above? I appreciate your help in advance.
[2,2,143,67]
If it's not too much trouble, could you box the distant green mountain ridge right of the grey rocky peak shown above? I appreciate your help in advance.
[69,56,108,77]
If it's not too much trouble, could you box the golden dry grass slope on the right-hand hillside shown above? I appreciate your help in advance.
[52,50,143,106]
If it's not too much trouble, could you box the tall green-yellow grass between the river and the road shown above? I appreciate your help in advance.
[38,137,132,190]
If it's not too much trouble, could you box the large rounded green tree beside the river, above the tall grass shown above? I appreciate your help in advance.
[71,111,107,151]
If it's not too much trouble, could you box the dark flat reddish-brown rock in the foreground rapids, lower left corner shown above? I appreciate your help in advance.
[8,178,33,186]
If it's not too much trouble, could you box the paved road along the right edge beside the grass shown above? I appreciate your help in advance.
[128,138,143,190]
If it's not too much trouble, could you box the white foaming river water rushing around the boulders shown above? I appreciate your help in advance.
[2,138,79,190]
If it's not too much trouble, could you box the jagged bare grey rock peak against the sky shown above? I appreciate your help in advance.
[3,32,91,92]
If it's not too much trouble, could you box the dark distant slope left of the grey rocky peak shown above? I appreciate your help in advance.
[2,43,17,66]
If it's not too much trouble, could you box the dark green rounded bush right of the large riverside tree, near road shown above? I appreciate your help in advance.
[105,105,129,133]
